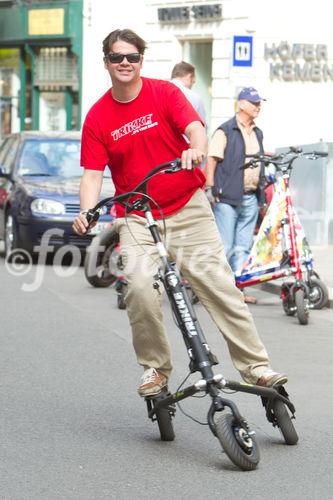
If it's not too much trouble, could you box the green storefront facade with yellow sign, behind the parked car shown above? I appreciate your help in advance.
[0,0,83,138]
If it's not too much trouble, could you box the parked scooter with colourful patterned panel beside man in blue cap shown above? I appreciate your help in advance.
[235,148,328,325]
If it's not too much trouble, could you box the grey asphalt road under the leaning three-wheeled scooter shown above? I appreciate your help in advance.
[0,259,333,500]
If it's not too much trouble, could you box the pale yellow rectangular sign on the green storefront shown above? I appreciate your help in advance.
[28,9,65,36]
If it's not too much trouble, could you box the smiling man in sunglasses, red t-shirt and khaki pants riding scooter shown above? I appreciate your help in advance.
[73,29,287,396]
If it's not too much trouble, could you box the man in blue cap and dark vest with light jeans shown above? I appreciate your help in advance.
[206,87,265,304]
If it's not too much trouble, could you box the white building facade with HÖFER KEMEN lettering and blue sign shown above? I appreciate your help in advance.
[82,0,333,150]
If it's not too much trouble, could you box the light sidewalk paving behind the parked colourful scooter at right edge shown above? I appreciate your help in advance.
[260,245,333,308]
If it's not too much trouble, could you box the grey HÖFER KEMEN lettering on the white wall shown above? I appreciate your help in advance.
[264,42,333,82]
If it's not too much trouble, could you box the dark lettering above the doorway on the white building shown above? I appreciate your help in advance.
[157,4,222,24]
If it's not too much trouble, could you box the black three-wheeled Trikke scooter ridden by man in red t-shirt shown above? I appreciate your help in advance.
[87,160,298,470]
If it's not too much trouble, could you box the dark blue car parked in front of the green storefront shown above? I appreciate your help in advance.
[0,131,114,256]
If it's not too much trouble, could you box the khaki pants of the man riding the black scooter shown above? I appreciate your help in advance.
[117,190,270,383]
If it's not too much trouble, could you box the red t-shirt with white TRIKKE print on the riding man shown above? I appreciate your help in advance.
[81,78,205,218]
